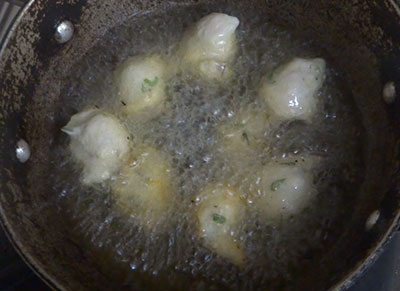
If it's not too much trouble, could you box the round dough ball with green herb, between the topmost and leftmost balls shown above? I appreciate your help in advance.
[114,55,166,114]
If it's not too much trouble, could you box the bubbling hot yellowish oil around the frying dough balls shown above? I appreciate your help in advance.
[51,3,363,290]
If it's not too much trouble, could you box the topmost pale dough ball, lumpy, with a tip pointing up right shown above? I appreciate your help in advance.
[180,13,239,80]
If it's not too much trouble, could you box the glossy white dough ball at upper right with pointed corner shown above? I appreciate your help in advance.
[260,58,325,120]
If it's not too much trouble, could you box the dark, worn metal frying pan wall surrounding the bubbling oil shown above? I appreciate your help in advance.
[0,0,400,290]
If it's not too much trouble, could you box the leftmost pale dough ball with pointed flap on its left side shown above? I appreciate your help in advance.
[61,109,129,184]
